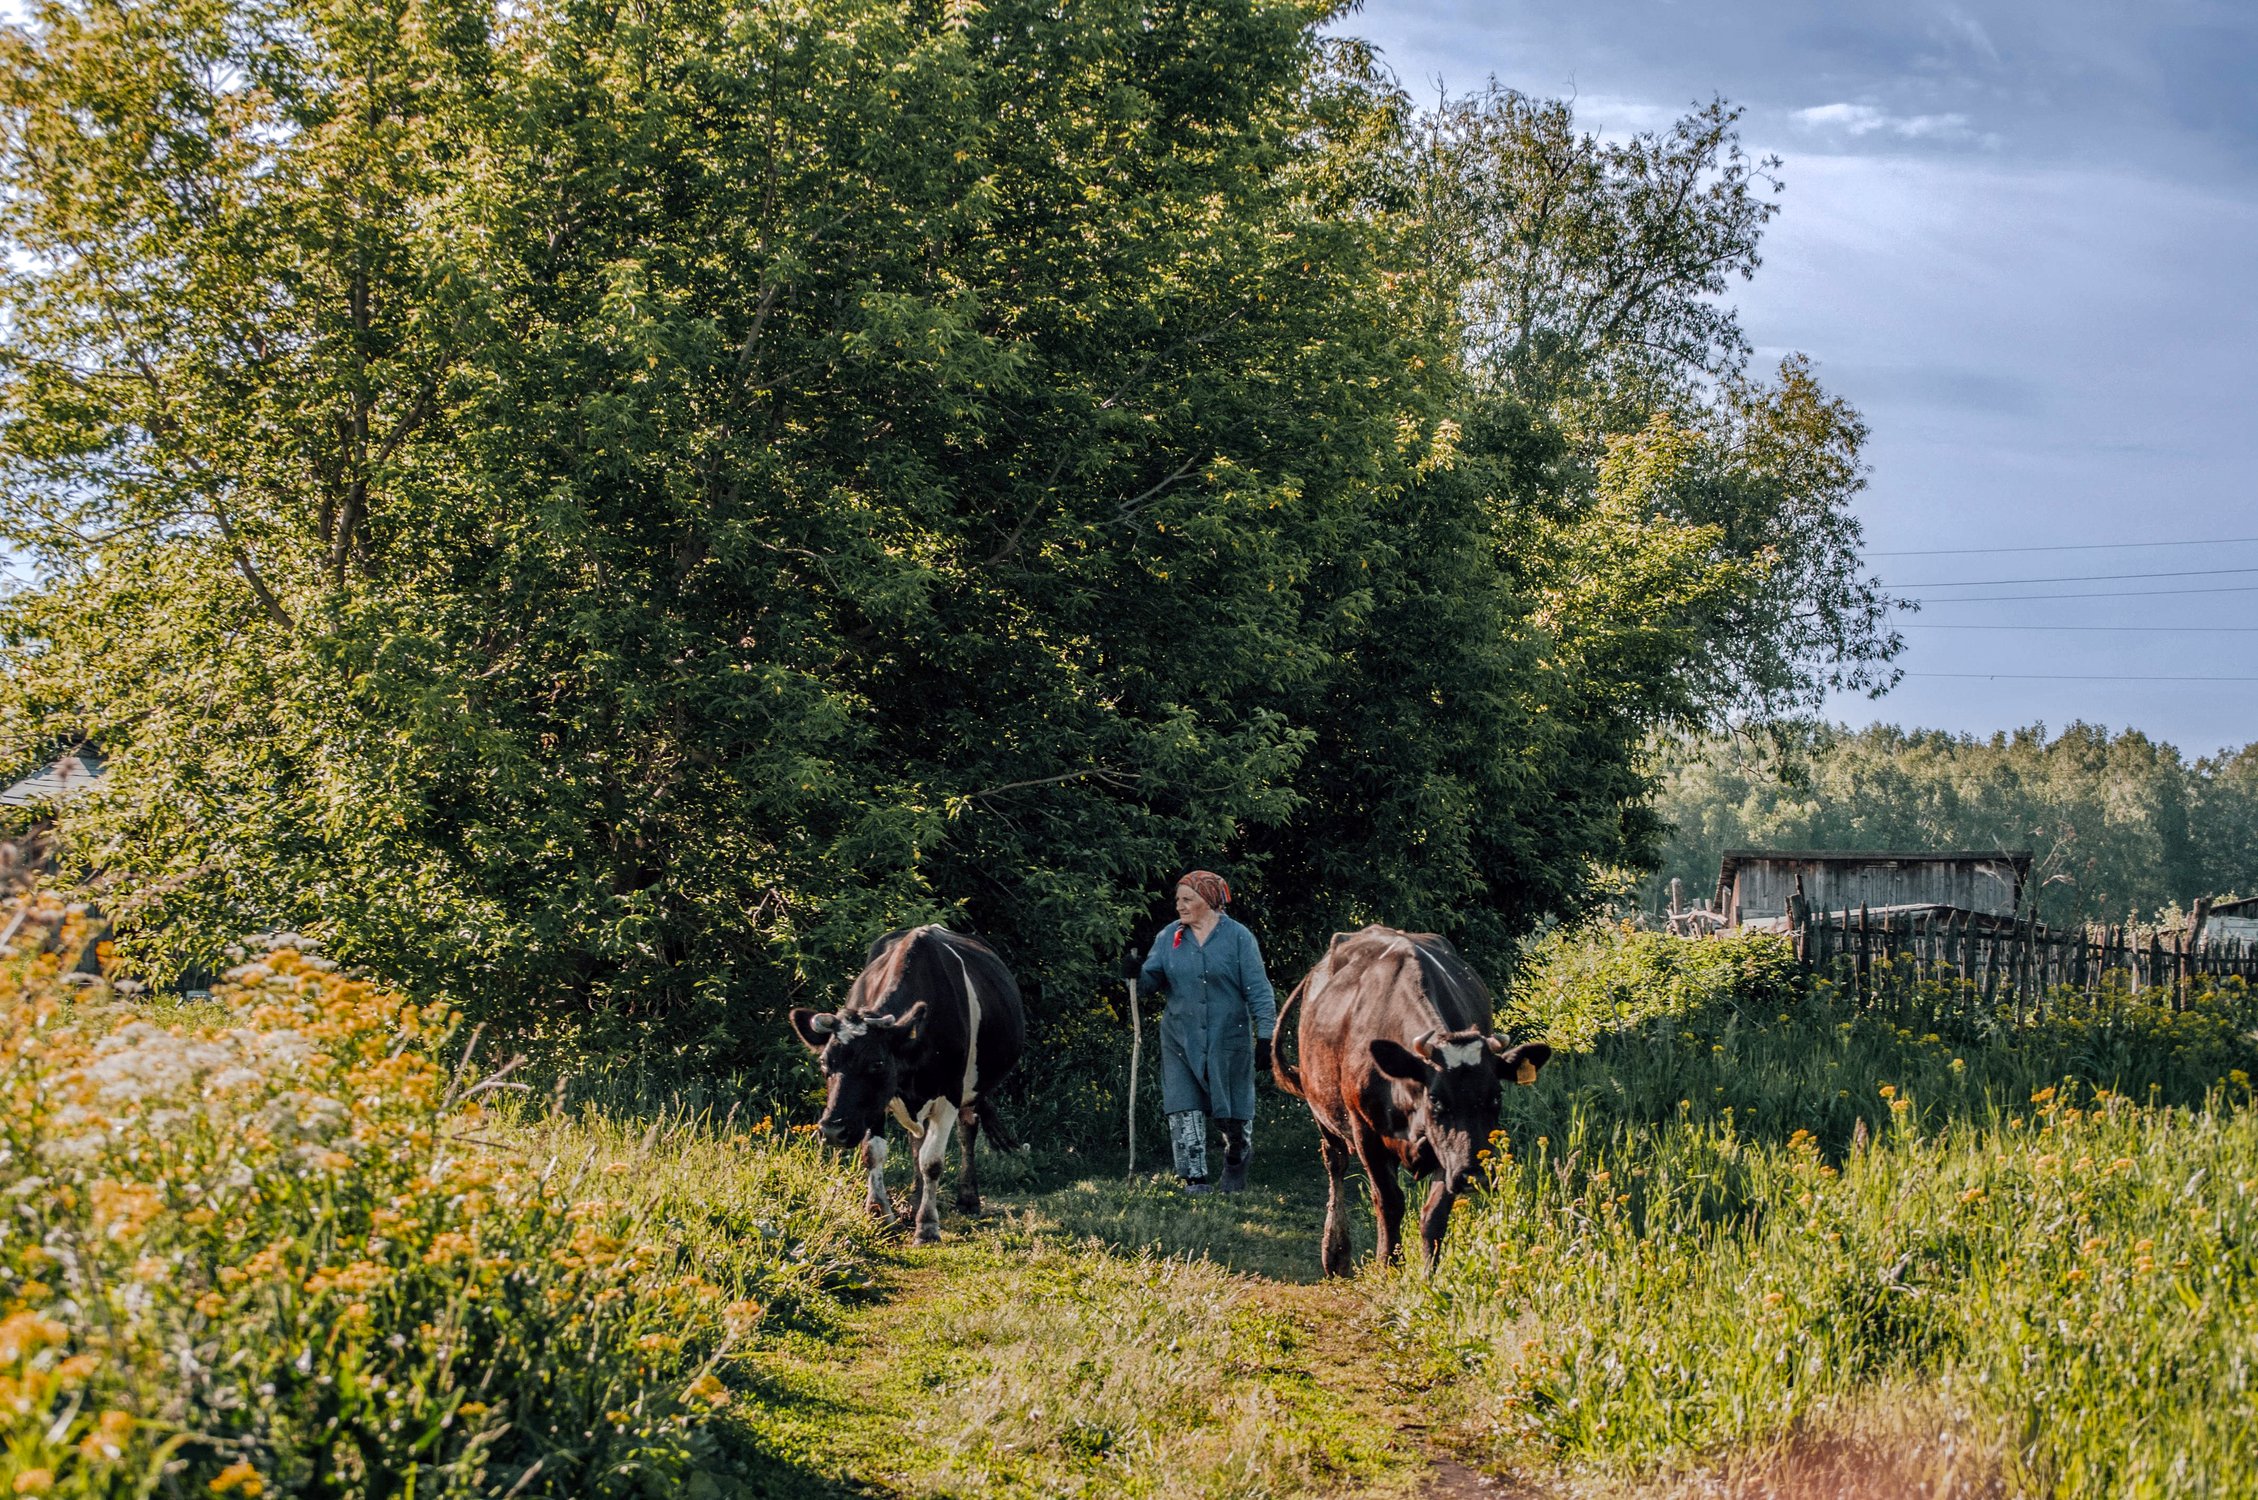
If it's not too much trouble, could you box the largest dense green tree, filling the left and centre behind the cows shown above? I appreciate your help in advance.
[0,0,1420,1062]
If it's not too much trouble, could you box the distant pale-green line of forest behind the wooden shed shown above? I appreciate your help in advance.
[1642,723,2258,922]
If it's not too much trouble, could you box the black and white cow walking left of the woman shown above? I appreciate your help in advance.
[793,926,1027,1245]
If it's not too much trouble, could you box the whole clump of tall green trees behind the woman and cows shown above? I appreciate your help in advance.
[0,0,1897,1078]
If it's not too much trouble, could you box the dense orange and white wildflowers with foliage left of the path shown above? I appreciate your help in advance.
[0,949,894,1495]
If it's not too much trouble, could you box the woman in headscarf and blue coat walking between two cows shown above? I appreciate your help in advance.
[1140,870,1278,1193]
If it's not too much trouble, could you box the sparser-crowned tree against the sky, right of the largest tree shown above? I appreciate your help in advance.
[1262,88,1899,948]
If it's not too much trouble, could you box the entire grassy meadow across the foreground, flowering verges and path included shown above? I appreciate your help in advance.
[0,908,2258,1500]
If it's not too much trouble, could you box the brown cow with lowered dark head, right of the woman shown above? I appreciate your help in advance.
[1271,926,1551,1276]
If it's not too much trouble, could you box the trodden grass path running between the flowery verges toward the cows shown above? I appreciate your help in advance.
[731,1097,1515,1500]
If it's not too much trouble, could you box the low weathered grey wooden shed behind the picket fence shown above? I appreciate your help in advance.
[1716,849,2030,926]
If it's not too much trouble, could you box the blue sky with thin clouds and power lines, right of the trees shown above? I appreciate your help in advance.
[1337,0,2258,755]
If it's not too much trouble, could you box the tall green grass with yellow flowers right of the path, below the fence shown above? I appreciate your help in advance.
[1395,933,2258,1493]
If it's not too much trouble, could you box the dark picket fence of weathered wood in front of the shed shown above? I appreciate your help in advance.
[1788,908,2258,1023]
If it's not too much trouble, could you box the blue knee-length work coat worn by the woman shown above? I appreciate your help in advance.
[1138,915,1278,1120]
